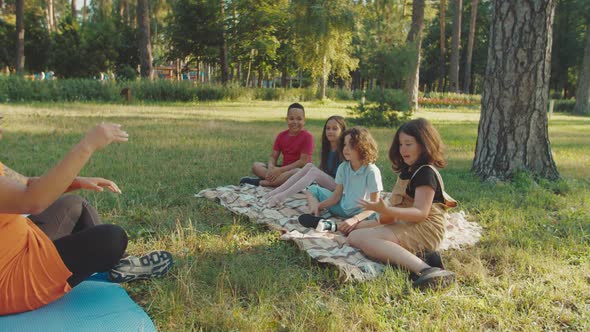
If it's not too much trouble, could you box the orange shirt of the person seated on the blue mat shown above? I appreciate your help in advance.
[0,163,72,315]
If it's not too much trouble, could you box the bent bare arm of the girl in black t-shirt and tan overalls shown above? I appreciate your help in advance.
[360,186,434,223]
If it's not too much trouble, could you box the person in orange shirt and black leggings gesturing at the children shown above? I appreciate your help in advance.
[0,123,128,315]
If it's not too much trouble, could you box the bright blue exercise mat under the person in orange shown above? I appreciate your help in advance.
[0,274,156,332]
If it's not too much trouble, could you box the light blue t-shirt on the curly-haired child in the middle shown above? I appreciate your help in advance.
[336,161,383,215]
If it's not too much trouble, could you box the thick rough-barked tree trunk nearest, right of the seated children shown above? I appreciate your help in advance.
[472,0,559,180]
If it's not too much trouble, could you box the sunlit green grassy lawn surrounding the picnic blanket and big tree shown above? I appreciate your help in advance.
[0,101,590,331]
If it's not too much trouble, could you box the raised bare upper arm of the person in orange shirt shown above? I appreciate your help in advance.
[0,124,128,214]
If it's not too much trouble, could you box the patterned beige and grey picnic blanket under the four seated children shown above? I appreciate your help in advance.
[195,185,482,281]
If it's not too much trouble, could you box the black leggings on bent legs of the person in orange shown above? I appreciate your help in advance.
[29,195,127,287]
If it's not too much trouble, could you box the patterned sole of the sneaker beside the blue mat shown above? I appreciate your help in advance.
[109,250,173,283]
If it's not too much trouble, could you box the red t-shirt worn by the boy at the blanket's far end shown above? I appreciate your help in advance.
[272,129,314,166]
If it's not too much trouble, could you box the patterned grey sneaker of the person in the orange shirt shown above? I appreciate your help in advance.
[108,250,173,283]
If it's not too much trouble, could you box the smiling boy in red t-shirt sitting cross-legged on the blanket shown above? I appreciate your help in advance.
[240,103,314,187]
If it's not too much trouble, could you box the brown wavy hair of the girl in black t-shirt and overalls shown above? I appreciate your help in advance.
[389,118,447,173]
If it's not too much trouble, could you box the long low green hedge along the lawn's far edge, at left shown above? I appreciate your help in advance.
[0,77,366,103]
